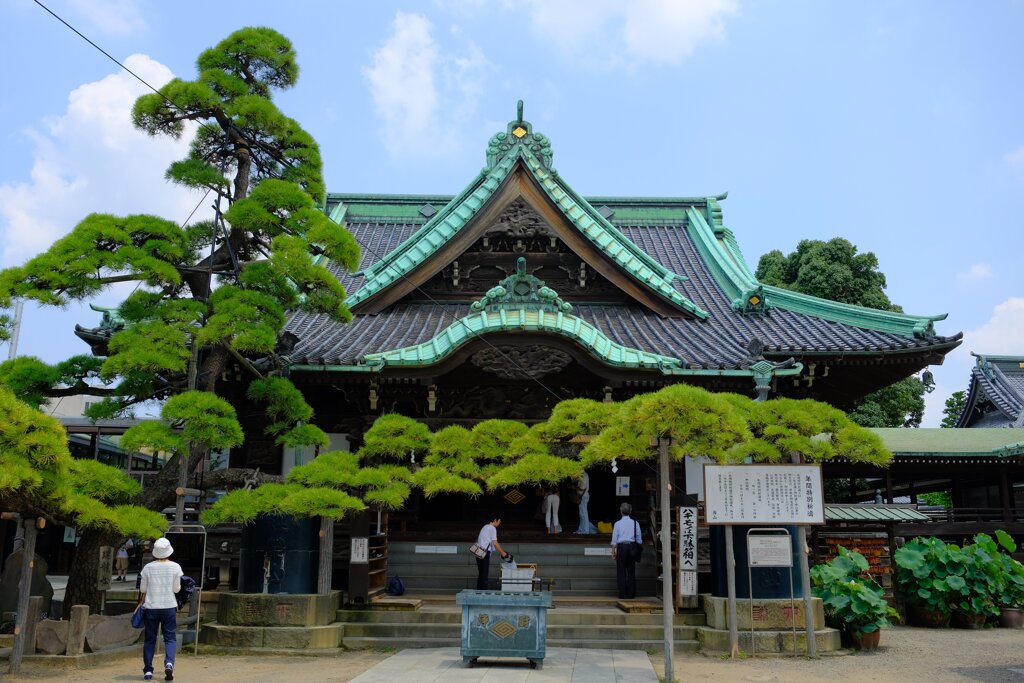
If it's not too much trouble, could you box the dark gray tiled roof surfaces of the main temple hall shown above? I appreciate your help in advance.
[288,221,956,368]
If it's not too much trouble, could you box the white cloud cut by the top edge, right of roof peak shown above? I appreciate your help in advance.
[516,0,739,66]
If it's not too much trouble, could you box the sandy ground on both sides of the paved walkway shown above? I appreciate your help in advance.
[8,627,1024,683]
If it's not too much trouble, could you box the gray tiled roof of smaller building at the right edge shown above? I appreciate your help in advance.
[956,353,1024,427]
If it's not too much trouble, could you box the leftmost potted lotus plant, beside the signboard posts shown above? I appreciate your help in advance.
[811,546,899,650]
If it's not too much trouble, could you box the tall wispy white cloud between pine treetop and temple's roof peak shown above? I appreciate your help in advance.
[362,11,489,157]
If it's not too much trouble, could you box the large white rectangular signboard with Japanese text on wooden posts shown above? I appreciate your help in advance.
[705,465,825,525]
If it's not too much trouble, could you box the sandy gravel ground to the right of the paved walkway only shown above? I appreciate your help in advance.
[650,627,1024,683]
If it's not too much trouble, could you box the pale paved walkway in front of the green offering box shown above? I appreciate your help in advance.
[352,647,657,683]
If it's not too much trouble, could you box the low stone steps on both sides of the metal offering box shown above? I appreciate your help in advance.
[337,602,705,651]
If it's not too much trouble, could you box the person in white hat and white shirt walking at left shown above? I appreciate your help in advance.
[138,539,181,681]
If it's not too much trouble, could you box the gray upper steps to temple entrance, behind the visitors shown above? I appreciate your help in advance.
[388,537,657,602]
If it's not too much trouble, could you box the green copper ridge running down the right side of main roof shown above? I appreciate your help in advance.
[686,207,947,337]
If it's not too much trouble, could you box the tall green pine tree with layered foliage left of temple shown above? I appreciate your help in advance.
[0,28,359,606]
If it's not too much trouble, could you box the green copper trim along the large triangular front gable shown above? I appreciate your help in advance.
[332,105,708,319]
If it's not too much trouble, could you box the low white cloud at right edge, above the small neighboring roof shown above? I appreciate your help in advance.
[922,297,1024,427]
